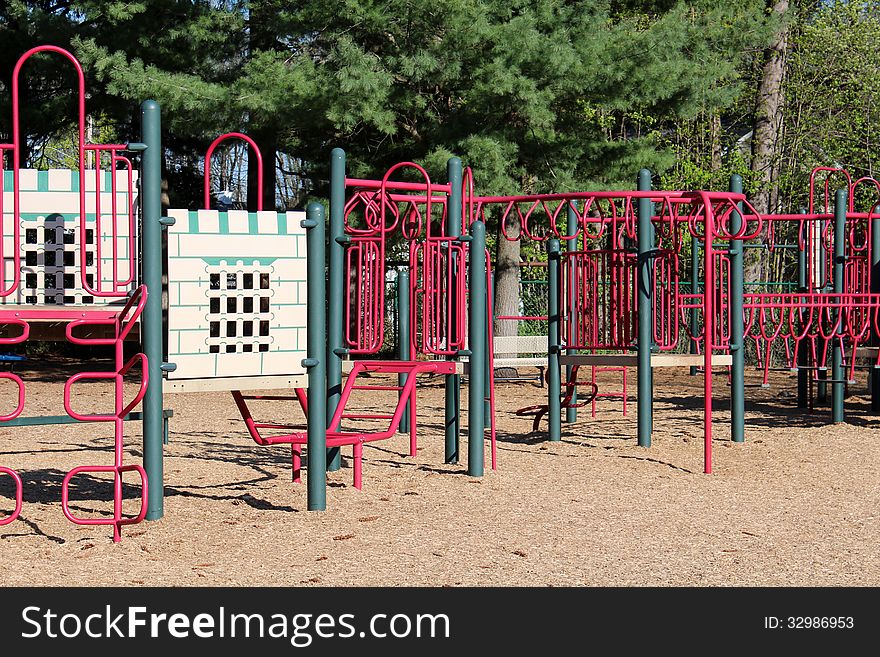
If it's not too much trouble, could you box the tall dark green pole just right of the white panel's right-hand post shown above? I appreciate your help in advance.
[327,148,345,472]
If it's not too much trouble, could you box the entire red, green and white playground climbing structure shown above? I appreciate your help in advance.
[0,46,880,541]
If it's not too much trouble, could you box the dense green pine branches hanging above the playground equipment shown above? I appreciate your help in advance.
[0,0,768,206]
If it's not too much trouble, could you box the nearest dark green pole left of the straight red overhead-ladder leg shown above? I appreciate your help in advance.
[636,169,652,447]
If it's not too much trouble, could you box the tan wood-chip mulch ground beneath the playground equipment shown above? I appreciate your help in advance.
[0,363,880,586]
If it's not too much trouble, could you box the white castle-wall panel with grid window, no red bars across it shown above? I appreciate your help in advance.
[168,210,307,379]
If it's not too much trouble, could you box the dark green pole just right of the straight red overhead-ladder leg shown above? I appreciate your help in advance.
[728,174,746,443]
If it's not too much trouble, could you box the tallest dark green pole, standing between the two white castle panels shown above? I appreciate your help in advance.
[141,100,165,520]
